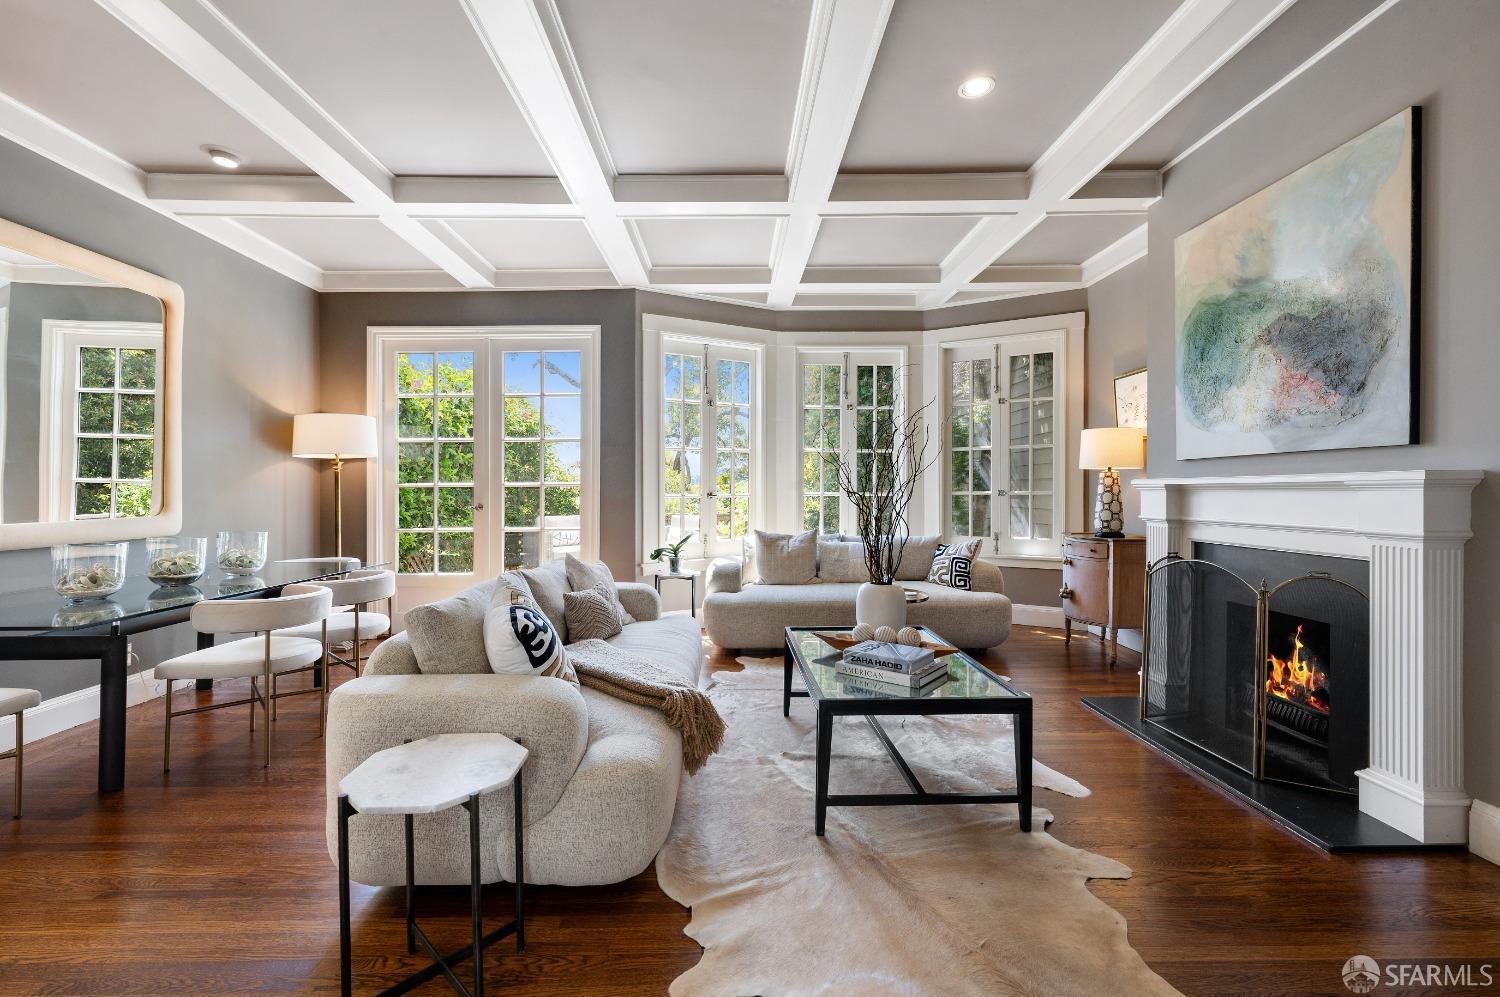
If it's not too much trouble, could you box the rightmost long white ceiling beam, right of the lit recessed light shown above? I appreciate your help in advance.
[923,0,1295,307]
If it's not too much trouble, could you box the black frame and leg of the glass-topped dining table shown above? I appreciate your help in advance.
[0,582,323,793]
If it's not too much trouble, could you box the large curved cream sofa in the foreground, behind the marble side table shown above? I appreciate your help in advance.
[327,582,704,886]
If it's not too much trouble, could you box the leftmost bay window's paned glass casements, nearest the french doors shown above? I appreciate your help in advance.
[662,339,756,555]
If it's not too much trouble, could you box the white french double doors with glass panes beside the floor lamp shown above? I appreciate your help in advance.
[374,331,599,606]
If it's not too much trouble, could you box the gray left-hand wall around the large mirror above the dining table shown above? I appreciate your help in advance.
[0,139,318,697]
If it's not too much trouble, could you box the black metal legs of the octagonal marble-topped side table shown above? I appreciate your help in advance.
[339,771,527,997]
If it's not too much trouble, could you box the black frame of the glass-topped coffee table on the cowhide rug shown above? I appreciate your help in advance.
[782,634,1032,837]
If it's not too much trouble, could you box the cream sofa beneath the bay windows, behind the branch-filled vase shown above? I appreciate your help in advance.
[704,559,1011,652]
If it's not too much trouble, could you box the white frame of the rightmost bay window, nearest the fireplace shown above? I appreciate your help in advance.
[923,312,1085,568]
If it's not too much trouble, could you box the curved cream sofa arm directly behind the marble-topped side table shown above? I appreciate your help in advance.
[326,673,588,886]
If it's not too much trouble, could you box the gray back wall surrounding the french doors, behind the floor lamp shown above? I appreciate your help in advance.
[318,291,641,579]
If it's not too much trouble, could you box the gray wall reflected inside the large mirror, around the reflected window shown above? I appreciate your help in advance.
[0,283,162,523]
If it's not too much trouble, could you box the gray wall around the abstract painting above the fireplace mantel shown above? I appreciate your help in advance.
[1146,0,1500,802]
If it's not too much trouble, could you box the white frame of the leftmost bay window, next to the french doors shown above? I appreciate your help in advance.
[641,315,768,573]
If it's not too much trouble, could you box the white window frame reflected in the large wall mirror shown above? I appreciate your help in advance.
[38,319,165,522]
